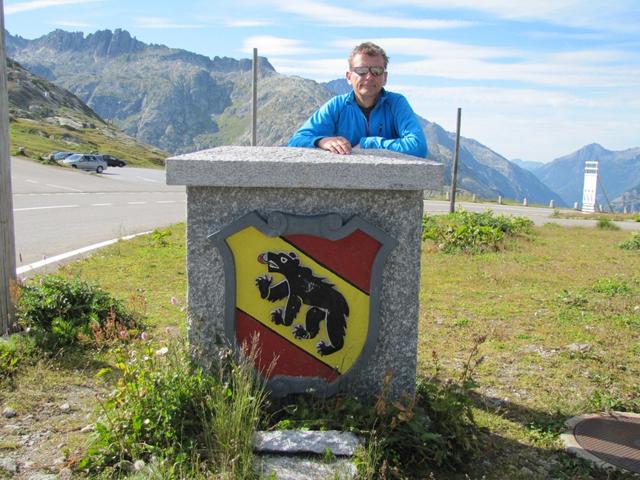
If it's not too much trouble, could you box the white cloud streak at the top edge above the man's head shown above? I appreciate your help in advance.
[276,0,471,30]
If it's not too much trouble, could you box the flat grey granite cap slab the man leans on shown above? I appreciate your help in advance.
[167,147,442,190]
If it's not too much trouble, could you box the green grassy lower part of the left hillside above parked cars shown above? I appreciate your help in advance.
[9,119,169,168]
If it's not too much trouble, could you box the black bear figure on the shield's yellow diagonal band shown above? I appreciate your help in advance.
[256,252,349,355]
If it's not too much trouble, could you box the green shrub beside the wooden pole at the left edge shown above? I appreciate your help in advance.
[16,275,140,351]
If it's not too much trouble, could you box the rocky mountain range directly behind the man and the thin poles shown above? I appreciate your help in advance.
[5,29,636,206]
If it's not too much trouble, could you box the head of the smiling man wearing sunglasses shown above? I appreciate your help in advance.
[347,42,389,107]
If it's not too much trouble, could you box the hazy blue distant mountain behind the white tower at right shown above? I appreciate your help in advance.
[536,143,640,208]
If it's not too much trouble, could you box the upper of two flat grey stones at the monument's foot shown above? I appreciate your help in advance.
[253,430,360,456]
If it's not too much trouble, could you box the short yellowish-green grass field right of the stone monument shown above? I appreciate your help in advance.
[418,225,640,479]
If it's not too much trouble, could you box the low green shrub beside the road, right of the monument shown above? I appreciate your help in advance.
[422,210,533,254]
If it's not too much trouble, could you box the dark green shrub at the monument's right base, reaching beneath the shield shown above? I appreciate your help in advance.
[269,337,485,479]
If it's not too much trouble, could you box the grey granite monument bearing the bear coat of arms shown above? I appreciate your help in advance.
[167,147,443,398]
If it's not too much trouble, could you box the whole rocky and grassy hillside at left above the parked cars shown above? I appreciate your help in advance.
[7,58,168,166]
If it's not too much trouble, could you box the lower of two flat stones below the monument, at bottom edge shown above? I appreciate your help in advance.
[255,455,358,480]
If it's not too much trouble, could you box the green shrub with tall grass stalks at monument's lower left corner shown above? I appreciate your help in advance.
[80,336,265,479]
